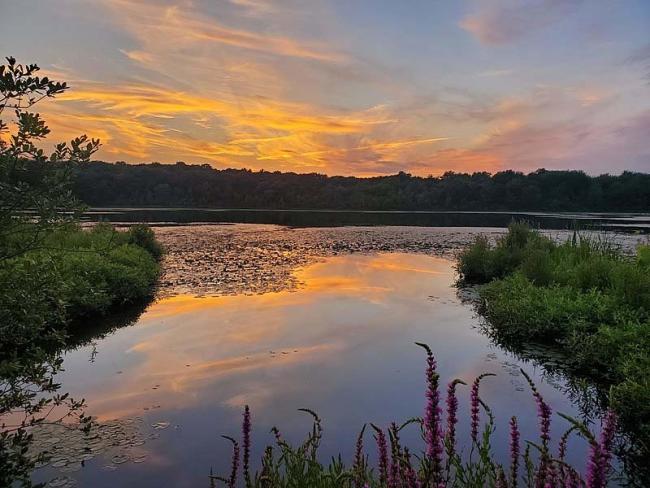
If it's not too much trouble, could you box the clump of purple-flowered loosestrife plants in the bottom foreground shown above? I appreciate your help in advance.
[210,344,616,488]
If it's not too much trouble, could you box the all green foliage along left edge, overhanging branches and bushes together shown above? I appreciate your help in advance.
[0,57,161,486]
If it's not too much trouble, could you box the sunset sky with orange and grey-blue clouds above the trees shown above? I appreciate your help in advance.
[0,0,650,176]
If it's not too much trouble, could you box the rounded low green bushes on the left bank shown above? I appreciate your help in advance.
[0,225,161,356]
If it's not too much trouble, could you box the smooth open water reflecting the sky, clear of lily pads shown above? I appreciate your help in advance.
[36,252,596,487]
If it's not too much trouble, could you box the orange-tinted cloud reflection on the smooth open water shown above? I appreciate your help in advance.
[63,254,452,419]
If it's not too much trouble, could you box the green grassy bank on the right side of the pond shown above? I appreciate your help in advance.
[458,224,650,480]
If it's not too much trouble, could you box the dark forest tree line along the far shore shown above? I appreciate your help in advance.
[67,161,650,212]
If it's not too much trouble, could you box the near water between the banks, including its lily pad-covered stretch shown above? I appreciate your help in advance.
[29,226,616,488]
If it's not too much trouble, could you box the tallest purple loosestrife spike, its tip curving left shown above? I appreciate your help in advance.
[416,342,443,482]
